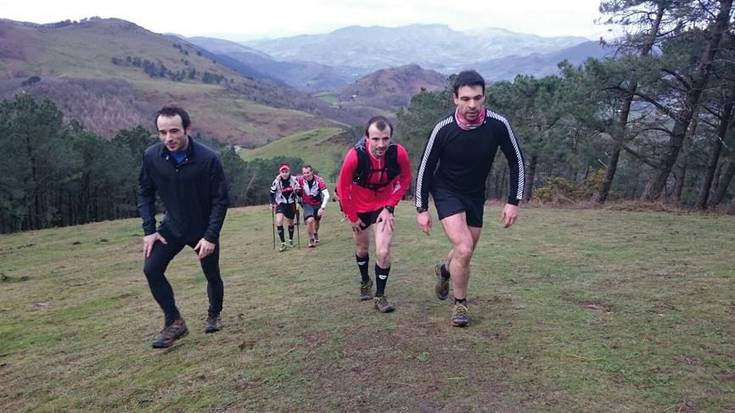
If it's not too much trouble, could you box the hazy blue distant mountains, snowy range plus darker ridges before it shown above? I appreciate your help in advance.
[188,24,611,93]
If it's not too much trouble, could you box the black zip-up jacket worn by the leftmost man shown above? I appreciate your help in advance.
[138,137,230,243]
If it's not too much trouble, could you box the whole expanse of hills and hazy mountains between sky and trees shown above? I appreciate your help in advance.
[0,18,610,147]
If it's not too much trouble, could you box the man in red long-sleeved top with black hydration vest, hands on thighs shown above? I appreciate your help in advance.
[337,116,411,313]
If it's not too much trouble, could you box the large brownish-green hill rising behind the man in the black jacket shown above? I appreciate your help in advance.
[0,18,334,146]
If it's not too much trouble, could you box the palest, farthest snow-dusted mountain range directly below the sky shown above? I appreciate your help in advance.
[244,24,589,75]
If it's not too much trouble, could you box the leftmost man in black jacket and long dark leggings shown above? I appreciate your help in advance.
[138,106,229,348]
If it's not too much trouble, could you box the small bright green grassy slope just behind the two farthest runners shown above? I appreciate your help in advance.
[240,128,353,177]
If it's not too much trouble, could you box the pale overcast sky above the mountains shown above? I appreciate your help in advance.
[0,0,607,40]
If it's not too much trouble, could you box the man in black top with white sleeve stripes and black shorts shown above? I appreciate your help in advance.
[416,70,525,327]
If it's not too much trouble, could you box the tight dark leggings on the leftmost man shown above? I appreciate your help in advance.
[143,237,224,323]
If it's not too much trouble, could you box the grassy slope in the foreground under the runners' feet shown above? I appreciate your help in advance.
[0,203,735,412]
